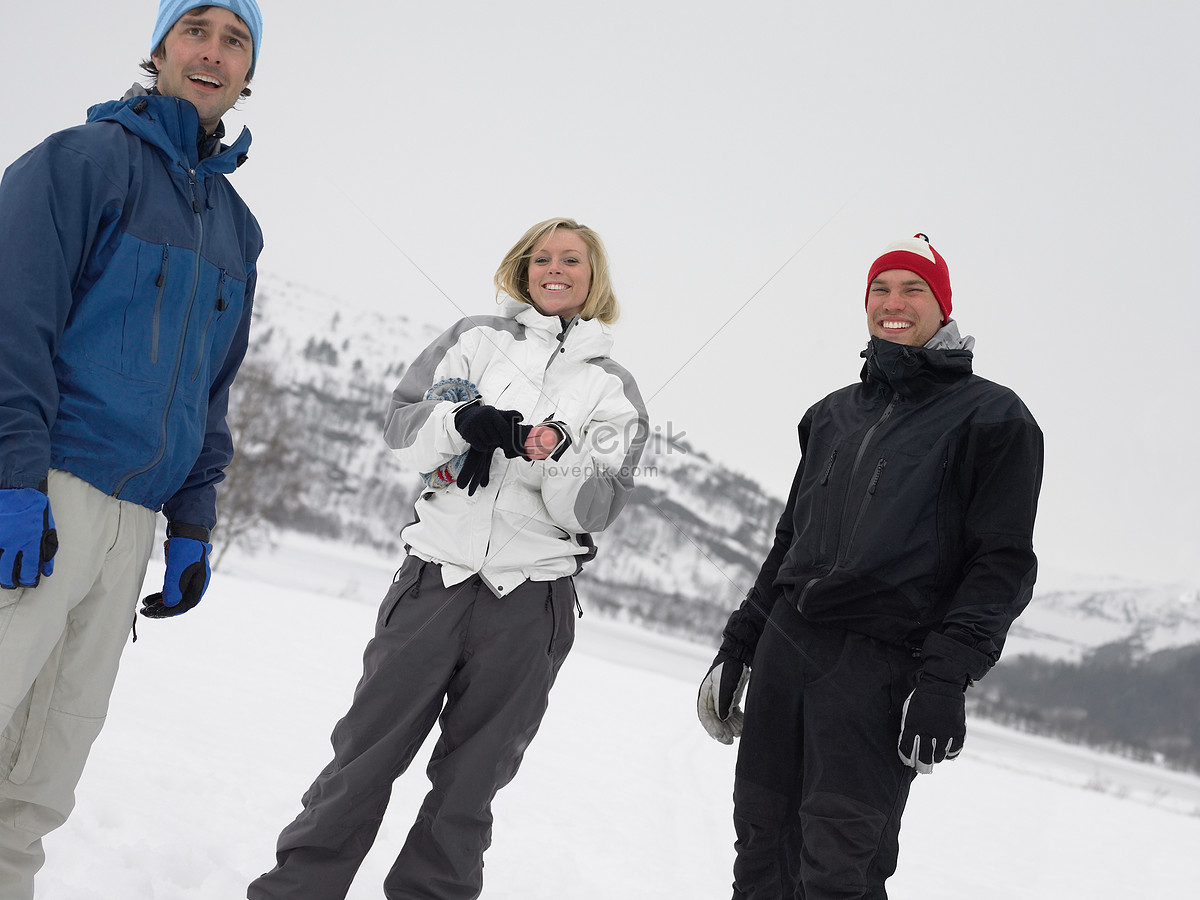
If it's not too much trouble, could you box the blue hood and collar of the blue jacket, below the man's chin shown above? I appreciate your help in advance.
[88,84,251,178]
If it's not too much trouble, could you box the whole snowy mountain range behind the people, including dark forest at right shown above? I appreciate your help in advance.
[216,278,1200,768]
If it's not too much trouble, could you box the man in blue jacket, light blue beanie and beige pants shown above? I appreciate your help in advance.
[0,0,262,900]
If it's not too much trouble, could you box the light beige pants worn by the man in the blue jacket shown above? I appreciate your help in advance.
[0,470,155,900]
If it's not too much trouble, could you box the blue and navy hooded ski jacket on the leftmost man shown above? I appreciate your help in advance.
[0,88,263,528]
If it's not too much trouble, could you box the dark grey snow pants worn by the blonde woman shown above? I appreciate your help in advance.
[247,557,576,900]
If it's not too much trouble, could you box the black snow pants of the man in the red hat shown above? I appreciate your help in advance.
[733,601,919,900]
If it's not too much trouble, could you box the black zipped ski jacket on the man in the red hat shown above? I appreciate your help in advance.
[721,338,1043,679]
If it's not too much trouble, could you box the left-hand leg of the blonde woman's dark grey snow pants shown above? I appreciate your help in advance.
[247,557,474,900]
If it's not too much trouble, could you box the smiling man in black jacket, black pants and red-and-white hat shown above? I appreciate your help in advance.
[697,235,1043,900]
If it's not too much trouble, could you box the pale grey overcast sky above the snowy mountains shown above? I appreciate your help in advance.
[0,0,1200,584]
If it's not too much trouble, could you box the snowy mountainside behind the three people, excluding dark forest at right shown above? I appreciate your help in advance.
[236,277,1200,660]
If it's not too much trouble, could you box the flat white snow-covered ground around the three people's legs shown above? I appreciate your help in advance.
[37,540,1200,900]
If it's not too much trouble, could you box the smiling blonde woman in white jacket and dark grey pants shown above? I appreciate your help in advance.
[248,218,648,900]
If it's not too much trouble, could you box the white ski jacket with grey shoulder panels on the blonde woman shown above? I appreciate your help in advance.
[384,300,649,596]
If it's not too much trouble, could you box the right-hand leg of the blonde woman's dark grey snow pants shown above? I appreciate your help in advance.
[384,578,575,900]
